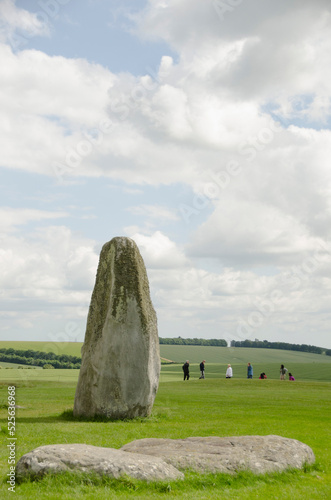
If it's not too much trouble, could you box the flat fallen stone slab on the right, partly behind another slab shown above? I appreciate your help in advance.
[121,435,315,474]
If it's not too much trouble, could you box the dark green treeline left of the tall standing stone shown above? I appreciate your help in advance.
[0,347,81,369]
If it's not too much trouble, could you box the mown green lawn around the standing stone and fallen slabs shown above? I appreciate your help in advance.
[0,365,331,499]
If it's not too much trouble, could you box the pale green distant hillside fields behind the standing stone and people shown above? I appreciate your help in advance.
[0,341,331,382]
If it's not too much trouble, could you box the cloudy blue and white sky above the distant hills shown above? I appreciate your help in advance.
[0,0,331,348]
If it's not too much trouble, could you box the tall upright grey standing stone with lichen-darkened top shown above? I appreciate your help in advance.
[74,237,160,419]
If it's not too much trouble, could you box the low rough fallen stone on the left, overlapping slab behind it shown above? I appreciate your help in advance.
[16,444,184,481]
